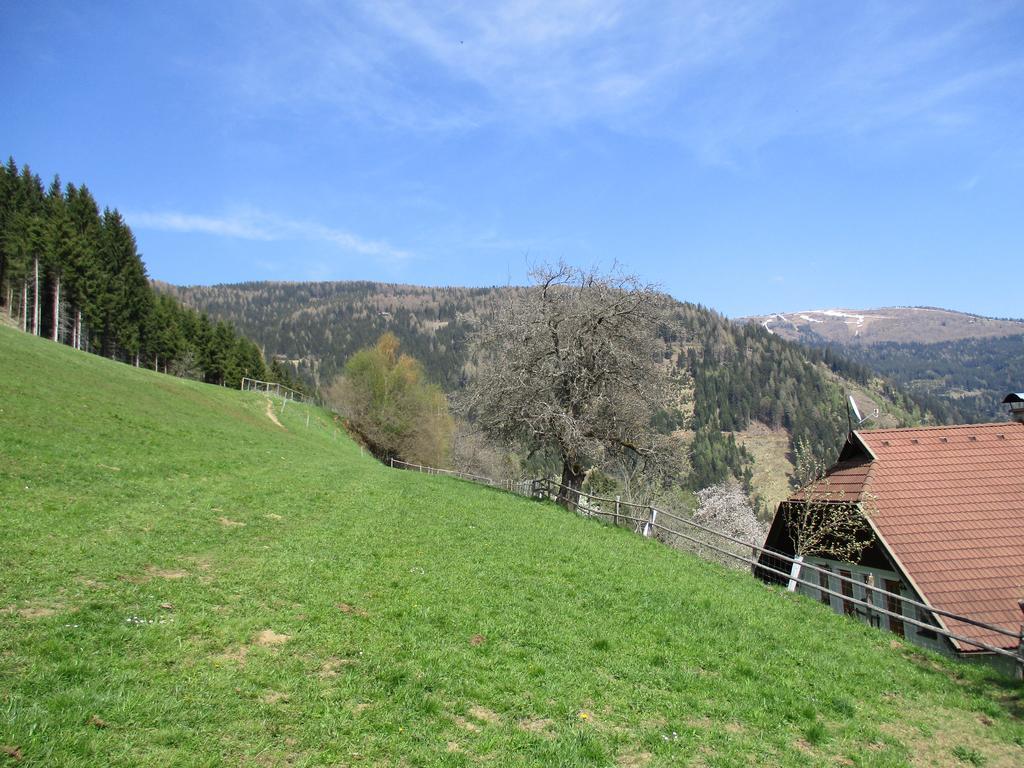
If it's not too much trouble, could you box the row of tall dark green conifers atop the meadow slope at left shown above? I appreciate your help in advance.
[0,158,294,393]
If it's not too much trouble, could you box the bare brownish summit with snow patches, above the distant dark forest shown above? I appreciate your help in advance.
[737,306,1024,345]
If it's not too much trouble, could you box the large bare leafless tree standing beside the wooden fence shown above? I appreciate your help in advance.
[463,263,677,506]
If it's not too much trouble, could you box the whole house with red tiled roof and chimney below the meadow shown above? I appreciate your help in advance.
[760,393,1024,669]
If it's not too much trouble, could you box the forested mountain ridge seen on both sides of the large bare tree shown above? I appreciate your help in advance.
[157,282,933,505]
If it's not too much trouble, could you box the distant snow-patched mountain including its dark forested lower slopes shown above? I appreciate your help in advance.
[738,307,1024,423]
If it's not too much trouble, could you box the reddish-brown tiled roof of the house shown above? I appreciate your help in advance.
[795,422,1024,651]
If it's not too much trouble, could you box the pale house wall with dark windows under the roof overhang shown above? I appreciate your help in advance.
[798,557,958,656]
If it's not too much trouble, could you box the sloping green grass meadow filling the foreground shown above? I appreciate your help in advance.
[0,328,1024,766]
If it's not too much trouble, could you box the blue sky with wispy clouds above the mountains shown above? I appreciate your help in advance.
[0,0,1024,316]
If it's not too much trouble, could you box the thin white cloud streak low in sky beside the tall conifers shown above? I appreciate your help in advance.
[125,210,412,262]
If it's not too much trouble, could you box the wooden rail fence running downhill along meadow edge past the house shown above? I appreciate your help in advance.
[391,459,1024,672]
